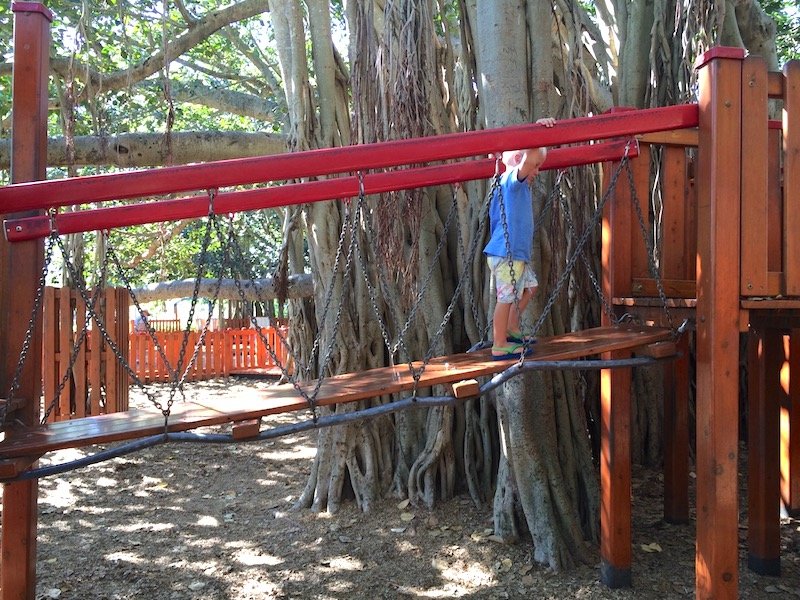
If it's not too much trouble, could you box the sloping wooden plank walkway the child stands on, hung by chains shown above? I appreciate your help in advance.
[0,326,671,477]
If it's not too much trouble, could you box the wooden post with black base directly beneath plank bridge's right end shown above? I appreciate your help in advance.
[600,351,632,588]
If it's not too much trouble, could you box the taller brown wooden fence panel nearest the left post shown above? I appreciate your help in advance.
[42,287,128,421]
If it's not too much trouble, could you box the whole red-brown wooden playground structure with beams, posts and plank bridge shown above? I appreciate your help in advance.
[0,3,800,598]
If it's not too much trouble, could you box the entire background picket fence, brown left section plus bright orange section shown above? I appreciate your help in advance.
[42,287,288,422]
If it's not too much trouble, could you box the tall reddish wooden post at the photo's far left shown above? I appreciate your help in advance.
[0,2,52,600]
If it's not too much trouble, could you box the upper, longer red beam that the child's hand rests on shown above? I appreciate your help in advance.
[0,104,698,214]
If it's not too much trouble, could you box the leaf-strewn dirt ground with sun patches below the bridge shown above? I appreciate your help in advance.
[4,381,800,600]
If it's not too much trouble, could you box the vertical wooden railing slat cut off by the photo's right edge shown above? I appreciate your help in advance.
[783,60,800,296]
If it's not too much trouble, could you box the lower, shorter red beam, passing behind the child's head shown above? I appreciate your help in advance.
[4,140,639,242]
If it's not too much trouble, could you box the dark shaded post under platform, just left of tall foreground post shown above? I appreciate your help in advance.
[664,334,689,523]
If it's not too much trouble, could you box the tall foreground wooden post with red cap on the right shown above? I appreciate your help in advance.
[695,47,744,600]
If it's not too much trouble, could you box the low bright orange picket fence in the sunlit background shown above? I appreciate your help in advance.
[128,327,288,383]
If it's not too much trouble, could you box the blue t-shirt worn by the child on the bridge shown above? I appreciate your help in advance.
[483,169,533,262]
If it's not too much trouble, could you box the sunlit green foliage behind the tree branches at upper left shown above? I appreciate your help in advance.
[0,0,300,285]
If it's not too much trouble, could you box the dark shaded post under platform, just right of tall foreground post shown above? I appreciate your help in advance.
[747,326,782,576]
